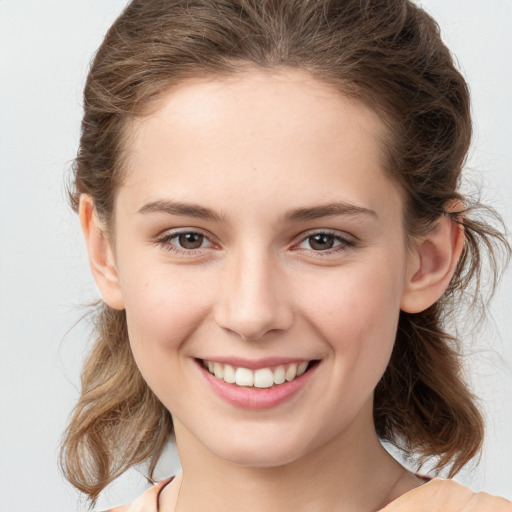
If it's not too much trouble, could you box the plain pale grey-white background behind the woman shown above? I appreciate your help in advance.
[0,0,512,512]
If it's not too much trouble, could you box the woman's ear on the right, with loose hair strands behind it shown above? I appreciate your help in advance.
[400,207,464,313]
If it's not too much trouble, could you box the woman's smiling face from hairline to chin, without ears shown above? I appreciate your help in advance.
[106,71,414,466]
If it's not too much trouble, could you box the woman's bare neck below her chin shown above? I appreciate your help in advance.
[164,402,412,512]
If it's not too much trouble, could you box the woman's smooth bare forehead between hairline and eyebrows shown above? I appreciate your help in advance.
[120,70,400,220]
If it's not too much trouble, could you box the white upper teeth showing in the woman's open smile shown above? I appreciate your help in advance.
[200,359,318,389]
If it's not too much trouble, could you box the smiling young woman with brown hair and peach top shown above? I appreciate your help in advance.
[62,0,512,512]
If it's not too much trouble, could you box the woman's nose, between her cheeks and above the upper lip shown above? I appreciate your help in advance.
[216,249,293,340]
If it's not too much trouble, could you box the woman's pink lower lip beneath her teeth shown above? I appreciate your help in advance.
[197,362,318,410]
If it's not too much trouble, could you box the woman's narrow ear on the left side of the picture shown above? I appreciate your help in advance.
[78,194,124,310]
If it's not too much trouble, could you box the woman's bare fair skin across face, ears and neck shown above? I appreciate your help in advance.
[80,70,463,512]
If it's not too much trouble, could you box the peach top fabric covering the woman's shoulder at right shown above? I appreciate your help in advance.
[381,478,512,512]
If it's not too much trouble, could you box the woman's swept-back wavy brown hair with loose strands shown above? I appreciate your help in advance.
[61,0,508,503]
